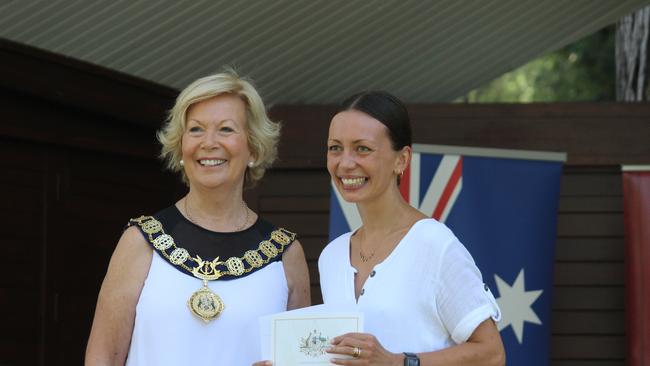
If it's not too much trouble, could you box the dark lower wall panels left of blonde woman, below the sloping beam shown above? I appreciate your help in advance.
[0,138,177,365]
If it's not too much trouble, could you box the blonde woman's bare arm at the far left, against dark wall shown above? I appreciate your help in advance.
[85,227,152,366]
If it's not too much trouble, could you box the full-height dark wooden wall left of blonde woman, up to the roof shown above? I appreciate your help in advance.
[0,41,180,365]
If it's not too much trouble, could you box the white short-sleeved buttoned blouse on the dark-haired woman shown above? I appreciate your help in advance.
[318,219,500,352]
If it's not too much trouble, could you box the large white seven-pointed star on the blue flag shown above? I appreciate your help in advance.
[494,268,544,344]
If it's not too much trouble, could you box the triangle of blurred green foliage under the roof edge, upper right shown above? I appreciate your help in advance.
[458,26,616,103]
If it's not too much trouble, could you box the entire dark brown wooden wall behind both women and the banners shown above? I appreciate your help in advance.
[0,38,650,366]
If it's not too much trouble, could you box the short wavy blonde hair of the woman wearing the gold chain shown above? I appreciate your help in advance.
[156,68,280,186]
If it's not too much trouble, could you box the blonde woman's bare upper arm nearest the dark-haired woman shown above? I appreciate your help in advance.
[282,240,311,310]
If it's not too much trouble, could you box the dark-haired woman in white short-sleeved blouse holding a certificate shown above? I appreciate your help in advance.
[318,92,505,366]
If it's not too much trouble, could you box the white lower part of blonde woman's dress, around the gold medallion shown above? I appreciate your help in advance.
[126,253,289,366]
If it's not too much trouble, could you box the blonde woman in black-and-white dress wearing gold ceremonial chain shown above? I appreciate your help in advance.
[86,71,310,366]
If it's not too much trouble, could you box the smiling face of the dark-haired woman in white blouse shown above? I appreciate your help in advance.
[327,110,401,203]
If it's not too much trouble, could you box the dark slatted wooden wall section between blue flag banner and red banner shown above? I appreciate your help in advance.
[551,166,625,366]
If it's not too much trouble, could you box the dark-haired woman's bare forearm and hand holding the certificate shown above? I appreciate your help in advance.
[328,319,506,366]
